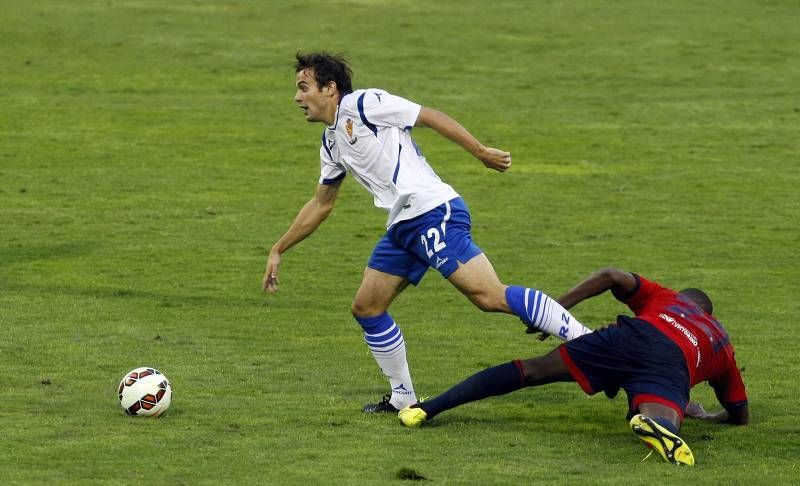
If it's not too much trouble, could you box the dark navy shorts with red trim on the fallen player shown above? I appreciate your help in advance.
[560,316,691,420]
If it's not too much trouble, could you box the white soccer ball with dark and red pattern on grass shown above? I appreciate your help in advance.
[119,367,172,417]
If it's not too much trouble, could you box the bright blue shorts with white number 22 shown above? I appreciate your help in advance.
[367,197,482,285]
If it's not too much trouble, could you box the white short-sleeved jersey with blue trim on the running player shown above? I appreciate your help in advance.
[319,89,458,227]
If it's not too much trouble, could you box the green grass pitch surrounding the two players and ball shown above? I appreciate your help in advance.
[0,0,800,484]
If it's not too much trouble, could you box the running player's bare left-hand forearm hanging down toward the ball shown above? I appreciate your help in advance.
[262,181,341,293]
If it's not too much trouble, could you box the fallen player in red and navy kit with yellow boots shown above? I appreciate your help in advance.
[398,268,749,465]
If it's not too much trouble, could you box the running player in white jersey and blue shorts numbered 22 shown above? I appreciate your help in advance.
[263,53,590,413]
